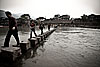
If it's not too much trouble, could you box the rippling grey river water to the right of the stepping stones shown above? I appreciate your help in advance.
[0,27,100,67]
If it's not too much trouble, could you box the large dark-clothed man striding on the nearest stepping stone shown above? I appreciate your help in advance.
[4,11,19,47]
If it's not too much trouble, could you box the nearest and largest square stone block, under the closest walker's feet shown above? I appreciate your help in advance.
[0,47,21,62]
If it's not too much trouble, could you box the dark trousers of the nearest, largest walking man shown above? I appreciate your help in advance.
[4,30,19,47]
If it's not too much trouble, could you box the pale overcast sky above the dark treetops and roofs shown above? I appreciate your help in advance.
[0,0,100,18]
